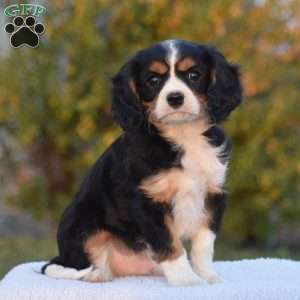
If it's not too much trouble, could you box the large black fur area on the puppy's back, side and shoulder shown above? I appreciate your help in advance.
[43,130,181,269]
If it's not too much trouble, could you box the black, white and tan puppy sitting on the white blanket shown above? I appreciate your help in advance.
[43,40,242,285]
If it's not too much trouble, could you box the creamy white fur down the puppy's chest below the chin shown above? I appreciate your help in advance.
[164,121,227,238]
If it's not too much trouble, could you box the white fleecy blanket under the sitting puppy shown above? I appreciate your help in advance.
[0,259,300,300]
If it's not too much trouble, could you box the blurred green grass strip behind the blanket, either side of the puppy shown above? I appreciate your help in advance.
[0,237,300,279]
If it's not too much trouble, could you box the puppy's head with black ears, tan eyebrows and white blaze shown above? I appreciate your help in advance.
[112,40,242,130]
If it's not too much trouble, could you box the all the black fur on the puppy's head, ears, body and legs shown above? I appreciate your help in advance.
[42,41,242,272]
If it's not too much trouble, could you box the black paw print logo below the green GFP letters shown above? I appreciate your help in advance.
[5,16,45,48]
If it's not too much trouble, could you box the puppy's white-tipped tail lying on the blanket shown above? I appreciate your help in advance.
[41,257,93,279]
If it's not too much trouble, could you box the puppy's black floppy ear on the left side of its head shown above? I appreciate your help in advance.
[112,60,144,131]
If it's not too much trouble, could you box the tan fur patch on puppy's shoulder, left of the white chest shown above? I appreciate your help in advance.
[140,168,180,203]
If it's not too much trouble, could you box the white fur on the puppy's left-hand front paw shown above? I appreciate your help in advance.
[160,251,204,285]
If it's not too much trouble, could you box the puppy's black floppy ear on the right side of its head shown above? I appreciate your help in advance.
[207,49,243,123]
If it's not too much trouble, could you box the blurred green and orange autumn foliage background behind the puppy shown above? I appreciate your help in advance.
[0,0,300,278]
